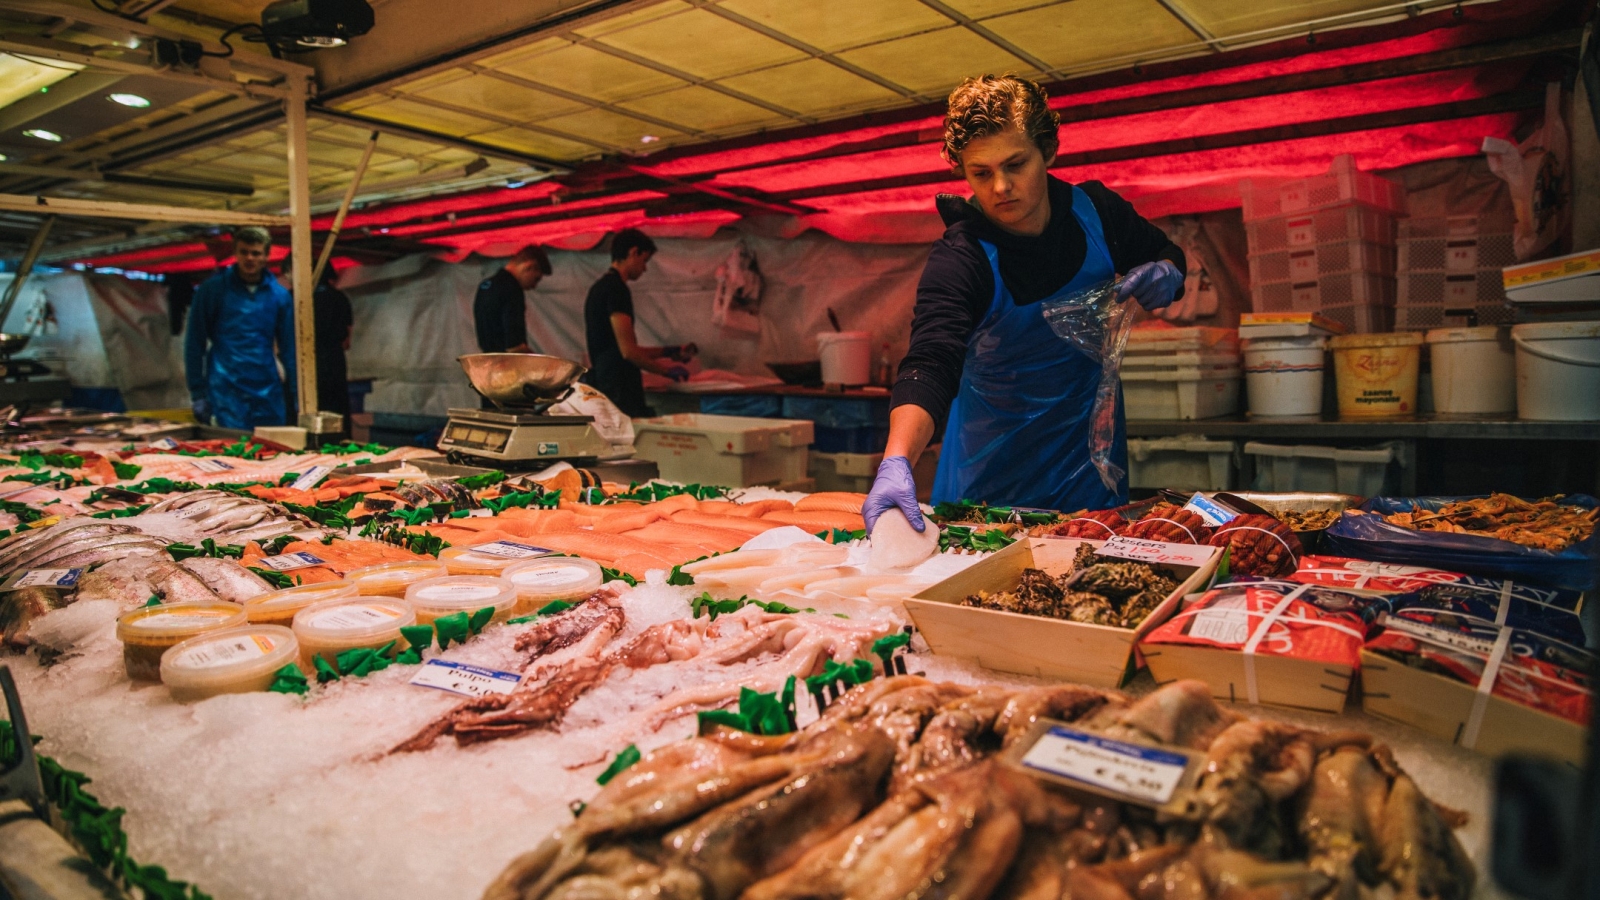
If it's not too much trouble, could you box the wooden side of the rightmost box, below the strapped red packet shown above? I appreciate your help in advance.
[1362,650,1587,765]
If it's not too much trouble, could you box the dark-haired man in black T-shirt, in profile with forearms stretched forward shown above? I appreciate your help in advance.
[584,227,698,418]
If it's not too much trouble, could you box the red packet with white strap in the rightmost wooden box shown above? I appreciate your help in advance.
[1366,609,1594,725]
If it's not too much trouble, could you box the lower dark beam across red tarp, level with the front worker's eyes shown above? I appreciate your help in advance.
[773,88,1544,202]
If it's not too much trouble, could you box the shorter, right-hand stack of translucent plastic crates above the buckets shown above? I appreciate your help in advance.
[1395,213,1517,330]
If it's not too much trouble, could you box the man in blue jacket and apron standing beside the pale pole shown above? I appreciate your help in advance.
[184,227,296,429]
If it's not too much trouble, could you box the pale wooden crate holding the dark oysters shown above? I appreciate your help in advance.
[906,538,1221,687]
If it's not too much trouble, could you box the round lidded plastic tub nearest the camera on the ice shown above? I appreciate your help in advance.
[162,625,299,703]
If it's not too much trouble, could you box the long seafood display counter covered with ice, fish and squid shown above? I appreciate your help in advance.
[0,436,1595,900]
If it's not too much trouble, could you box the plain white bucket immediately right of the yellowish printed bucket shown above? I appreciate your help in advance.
[1427,325,1517,416]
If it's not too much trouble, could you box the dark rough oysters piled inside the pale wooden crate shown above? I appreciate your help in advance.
[962,544,1179,628]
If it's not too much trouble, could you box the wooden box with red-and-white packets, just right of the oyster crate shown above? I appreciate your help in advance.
[1139,580,1382,713]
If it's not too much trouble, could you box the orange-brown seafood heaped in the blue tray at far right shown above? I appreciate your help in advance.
[1384,493,1600,552]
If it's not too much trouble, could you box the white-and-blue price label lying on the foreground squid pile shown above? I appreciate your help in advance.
[1021,725,1190,806]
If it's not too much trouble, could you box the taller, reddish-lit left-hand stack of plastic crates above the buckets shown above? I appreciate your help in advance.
[1240,157,1405,331]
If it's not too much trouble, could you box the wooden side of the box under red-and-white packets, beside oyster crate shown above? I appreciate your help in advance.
[1139,644,1355,713]
